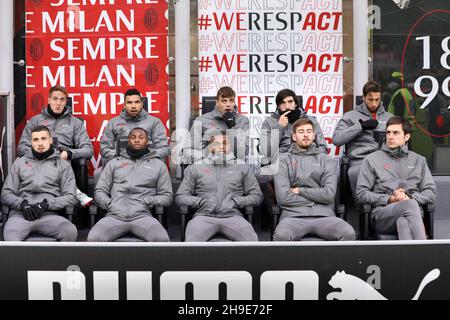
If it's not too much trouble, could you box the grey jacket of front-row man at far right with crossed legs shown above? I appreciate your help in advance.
[356,144,436,207]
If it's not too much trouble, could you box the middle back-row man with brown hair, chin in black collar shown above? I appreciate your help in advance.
[183,87,250,163]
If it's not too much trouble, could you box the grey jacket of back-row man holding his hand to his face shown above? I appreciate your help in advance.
[259,109,327,157]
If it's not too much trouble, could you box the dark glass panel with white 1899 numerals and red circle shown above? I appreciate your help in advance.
[373,0,450,175]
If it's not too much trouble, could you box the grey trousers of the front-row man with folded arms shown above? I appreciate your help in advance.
[273,217,355,241]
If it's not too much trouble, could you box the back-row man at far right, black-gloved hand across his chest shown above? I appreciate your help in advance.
[333,81,392,196]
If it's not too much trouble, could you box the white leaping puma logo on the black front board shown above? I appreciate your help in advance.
[327,269,441,300]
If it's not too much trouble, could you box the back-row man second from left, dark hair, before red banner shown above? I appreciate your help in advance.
[100,89,170,167]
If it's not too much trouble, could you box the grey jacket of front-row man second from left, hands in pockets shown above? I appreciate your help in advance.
[95,150,173,221]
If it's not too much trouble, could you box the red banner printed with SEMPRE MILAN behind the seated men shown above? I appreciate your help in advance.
[25,0,169,172]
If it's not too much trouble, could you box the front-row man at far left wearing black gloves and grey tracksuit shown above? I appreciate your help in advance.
[1,125,77,241]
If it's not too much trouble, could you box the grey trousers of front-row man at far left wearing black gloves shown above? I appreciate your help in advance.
[3,214,78,241]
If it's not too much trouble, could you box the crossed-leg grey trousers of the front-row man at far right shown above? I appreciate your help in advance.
[372,200,427,240]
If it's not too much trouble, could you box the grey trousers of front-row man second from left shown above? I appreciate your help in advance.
[87,216,170,242]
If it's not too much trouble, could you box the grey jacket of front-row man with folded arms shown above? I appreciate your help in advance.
[274,143,337,218]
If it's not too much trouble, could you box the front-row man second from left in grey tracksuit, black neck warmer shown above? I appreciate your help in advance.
[88,128,173,241]
